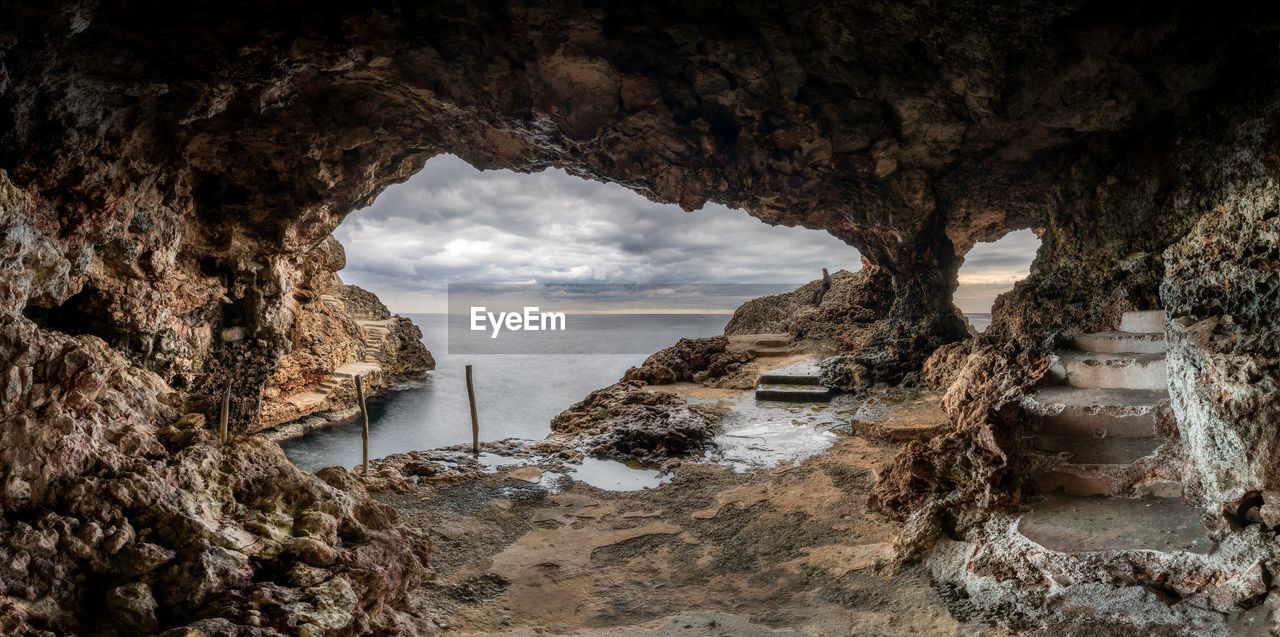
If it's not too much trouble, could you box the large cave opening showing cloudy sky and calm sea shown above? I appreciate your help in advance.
[284,155,890,468]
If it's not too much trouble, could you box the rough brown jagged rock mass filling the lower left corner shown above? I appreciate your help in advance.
[0,316,430,634]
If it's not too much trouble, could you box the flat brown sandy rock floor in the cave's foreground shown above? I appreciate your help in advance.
[379,388,1004,636]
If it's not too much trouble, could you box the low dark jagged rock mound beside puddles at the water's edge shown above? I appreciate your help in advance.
[550,380,719,463]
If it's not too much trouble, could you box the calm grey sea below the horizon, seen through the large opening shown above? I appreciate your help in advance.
[282,315,730,471]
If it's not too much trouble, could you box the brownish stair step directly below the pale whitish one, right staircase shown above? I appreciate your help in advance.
[1023,385,1169,437]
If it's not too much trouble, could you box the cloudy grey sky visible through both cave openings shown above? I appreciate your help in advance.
[334,155,1038,313]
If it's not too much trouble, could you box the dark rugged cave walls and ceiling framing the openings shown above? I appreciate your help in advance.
[0,0,1280,634]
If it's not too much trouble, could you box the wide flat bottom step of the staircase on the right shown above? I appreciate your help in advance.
[1018,496,1213,554]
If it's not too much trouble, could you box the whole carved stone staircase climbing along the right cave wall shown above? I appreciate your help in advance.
[1018,310,1207,553]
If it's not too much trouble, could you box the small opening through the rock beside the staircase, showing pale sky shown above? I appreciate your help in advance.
[954,230,1041,331]
